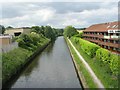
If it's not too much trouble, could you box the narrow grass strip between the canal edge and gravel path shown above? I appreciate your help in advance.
[66,39,97,88]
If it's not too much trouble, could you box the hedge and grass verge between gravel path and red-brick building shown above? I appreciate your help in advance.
[70,36,119,88]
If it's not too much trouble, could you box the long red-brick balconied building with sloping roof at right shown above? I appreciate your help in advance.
[83,22,120,54]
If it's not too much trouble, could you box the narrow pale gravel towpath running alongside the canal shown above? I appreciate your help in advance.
[68,39,104,90]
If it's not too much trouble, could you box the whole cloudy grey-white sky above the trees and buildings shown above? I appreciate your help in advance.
[0,2,118,28]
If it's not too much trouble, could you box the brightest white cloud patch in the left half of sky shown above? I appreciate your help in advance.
[0,9,55,27]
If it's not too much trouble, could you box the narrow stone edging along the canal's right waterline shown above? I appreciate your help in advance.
[64,37,88,90]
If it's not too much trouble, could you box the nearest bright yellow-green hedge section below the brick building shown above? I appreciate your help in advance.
[96,48,120,75]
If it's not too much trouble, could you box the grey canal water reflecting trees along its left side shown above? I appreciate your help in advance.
[7,37,81,88]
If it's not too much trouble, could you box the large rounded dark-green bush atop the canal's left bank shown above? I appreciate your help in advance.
[17,32,48,51]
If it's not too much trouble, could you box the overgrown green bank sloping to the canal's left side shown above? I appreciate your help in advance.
[2,39,50,88]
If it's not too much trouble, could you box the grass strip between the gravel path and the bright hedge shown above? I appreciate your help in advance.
[70,37,118,88]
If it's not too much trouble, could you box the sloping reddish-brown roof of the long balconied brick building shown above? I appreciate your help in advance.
[84,21,120,32]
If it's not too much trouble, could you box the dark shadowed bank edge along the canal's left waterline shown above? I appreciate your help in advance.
[2,41,51,89]
